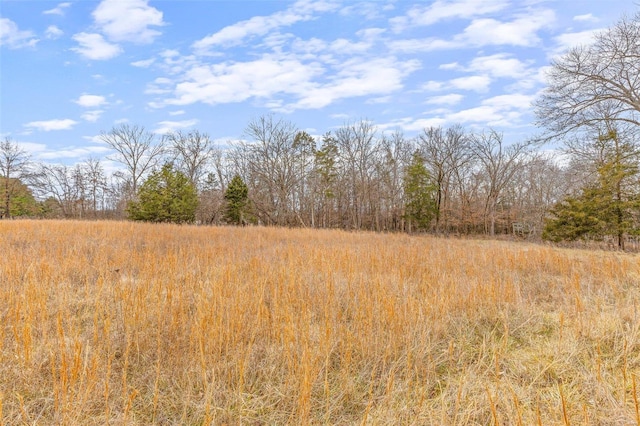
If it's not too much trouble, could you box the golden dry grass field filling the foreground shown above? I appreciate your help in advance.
[0,221,640,425]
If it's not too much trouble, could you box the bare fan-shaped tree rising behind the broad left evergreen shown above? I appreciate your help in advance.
[100,124,165,197]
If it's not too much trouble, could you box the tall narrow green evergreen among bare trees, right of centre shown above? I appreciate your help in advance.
[404,152,436,229]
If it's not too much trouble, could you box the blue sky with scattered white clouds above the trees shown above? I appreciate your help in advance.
[0,0,638,164]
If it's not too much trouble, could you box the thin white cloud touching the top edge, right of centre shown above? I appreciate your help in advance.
[390,0,509,32]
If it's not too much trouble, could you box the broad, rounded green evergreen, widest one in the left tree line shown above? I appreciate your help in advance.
[127,164,198,223]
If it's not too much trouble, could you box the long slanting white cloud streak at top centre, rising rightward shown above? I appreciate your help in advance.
[192,0,338,54]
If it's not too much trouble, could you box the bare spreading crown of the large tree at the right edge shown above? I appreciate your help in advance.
[535,14,640,136]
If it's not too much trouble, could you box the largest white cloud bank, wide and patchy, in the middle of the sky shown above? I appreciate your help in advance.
[151,46,420,113]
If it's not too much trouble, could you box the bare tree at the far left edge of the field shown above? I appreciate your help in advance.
[0,137,31,218]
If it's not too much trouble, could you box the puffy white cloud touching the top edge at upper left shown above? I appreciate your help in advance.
[93,0,164,44]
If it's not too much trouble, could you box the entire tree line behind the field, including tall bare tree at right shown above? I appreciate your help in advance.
[0,10,640,248]
